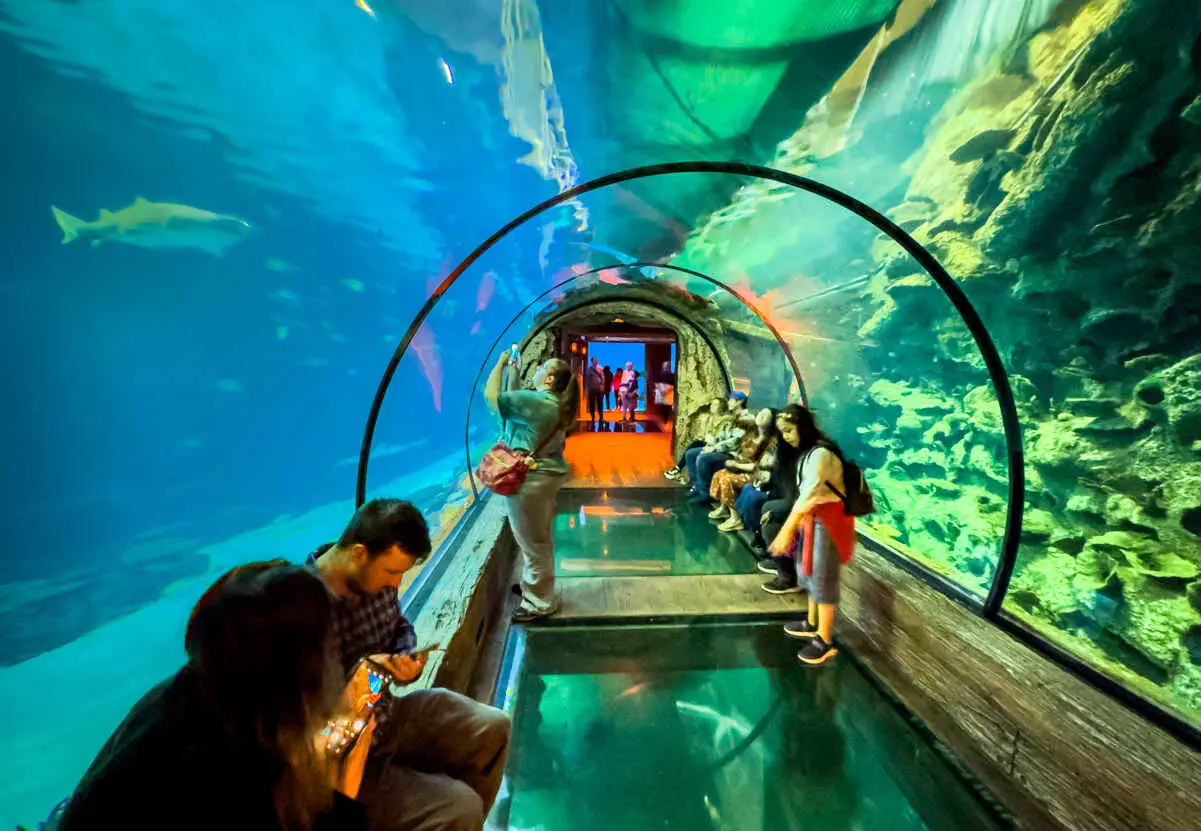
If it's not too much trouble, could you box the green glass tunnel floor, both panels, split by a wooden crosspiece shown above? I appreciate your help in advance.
[488,486,1011,831]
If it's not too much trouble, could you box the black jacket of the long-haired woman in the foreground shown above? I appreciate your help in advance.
[59,666,366,831]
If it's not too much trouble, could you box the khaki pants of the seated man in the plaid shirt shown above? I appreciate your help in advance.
[358,689,509,831]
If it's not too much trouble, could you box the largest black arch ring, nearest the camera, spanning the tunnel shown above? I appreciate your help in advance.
[355,161,1026,618]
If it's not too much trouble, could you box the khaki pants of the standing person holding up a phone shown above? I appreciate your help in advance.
[507,471,567,615]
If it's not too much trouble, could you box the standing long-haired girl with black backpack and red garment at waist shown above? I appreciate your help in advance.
[764,405,855,664]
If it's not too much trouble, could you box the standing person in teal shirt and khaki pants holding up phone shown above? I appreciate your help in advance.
[484,352,580,623]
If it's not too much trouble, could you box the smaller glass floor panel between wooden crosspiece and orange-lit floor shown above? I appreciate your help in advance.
[555,488,754,576]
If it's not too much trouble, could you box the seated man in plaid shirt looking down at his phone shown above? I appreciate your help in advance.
[309,500,509,831]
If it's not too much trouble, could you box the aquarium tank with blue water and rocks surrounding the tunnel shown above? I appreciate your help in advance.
[0,0,1201,829]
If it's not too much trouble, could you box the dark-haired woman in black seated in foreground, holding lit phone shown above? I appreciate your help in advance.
[60,560,374,831]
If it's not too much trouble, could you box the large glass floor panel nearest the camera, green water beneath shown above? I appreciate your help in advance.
[490,624,1003,831]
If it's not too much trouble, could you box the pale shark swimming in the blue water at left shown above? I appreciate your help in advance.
[50,196,252,257]
